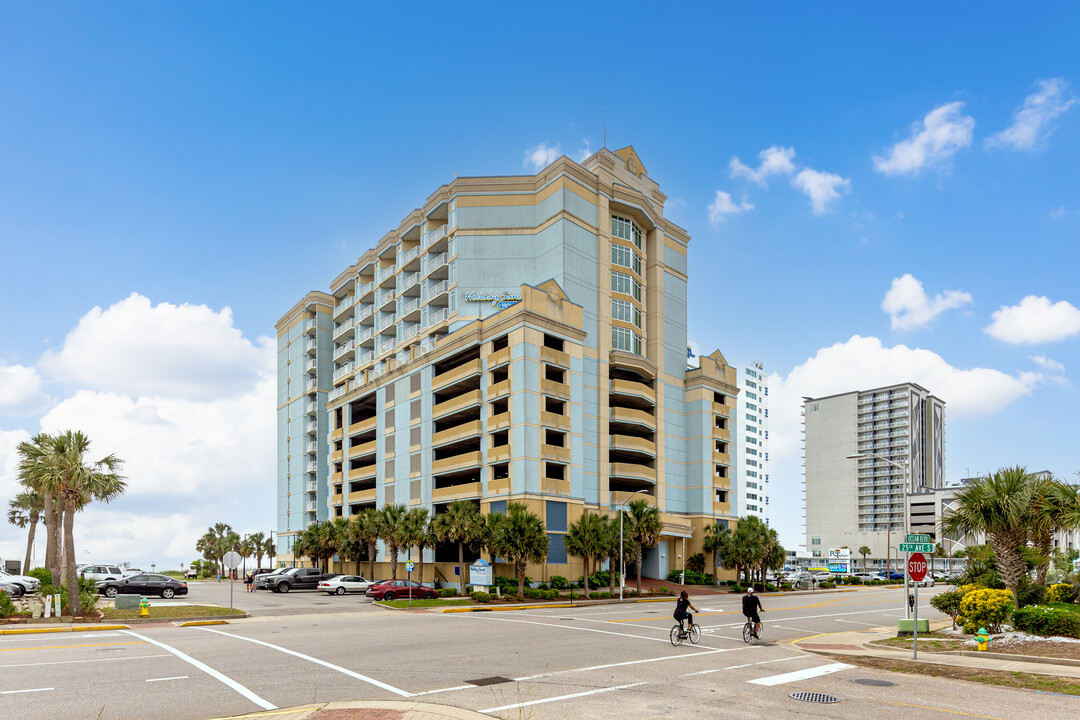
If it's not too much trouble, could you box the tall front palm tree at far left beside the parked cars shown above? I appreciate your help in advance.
[18,431,127,615]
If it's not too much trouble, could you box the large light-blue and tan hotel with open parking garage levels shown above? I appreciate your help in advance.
[278,147,738,581]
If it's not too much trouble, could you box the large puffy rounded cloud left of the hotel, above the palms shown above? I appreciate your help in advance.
[40,293,271,399]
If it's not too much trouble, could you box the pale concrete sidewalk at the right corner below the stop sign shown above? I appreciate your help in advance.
[792,621,1080,678]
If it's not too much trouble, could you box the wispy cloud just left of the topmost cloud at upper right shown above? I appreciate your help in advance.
[874,103,975,175]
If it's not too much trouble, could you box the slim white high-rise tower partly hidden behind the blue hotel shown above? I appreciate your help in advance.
[735,363,769,525]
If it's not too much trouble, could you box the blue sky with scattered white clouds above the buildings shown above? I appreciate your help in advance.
[0,2,1080,565]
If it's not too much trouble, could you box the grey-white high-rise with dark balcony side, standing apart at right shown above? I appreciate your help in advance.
[802,382,945,559]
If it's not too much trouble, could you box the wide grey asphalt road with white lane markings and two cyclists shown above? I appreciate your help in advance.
[0,588,1080,720]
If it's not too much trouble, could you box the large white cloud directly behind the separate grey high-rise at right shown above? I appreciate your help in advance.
[769,335,1047,547]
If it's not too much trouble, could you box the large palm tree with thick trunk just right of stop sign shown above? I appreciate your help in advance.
[941,466,1036,599]
